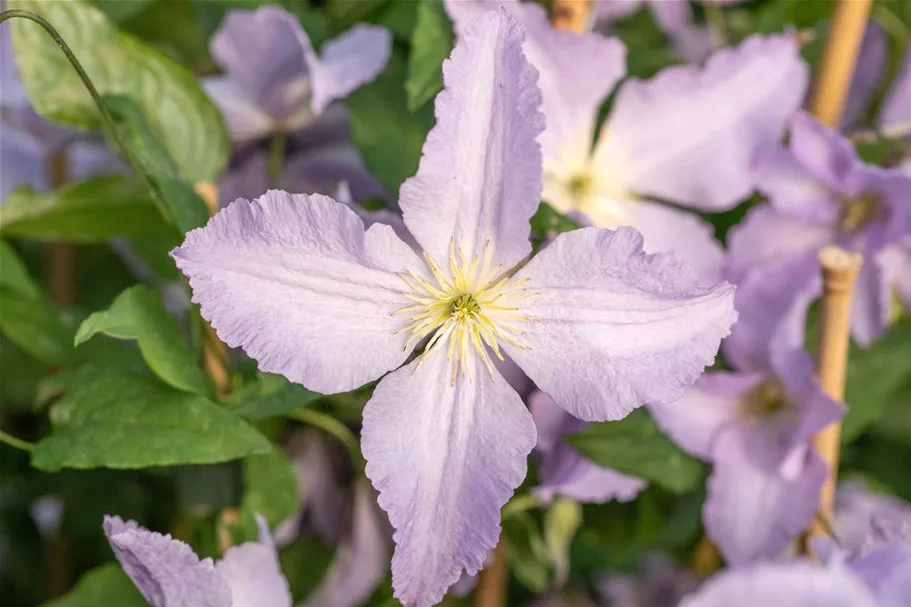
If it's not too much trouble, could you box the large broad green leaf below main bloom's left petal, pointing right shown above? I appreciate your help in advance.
[32,365,272,472]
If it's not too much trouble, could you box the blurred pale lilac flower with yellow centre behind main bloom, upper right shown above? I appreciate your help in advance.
[446,0,807,281]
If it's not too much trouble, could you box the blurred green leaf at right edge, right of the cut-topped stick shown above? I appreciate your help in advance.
[841,318,911,442]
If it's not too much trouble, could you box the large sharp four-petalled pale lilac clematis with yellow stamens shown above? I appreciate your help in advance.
[172,11,735,606]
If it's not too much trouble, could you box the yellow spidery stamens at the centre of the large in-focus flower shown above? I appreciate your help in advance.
[394,241,534,382]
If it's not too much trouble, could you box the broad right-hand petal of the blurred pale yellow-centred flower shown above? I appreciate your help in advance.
[595,36,807,211]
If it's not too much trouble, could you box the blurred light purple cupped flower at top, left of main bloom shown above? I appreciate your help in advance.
[203,6,392,142]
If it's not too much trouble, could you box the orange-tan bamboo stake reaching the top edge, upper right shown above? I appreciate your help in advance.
[810,0,872,126]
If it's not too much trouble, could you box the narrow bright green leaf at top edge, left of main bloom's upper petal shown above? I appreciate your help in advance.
[405,1,452,112]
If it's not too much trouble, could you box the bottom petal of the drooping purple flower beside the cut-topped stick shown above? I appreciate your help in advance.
[703,426,826,566]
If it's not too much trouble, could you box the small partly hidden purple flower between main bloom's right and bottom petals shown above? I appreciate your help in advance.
[528,392,648,504]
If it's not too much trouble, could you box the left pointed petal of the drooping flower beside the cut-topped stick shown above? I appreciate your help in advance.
[649,371,765,461]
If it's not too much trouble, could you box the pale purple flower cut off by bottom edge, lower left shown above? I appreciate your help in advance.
[104,516,291,607]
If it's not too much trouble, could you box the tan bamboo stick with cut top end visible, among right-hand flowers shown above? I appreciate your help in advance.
[807,246,862,552]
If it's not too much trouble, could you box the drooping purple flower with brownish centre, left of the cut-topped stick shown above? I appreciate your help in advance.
[651,324,844,565]
